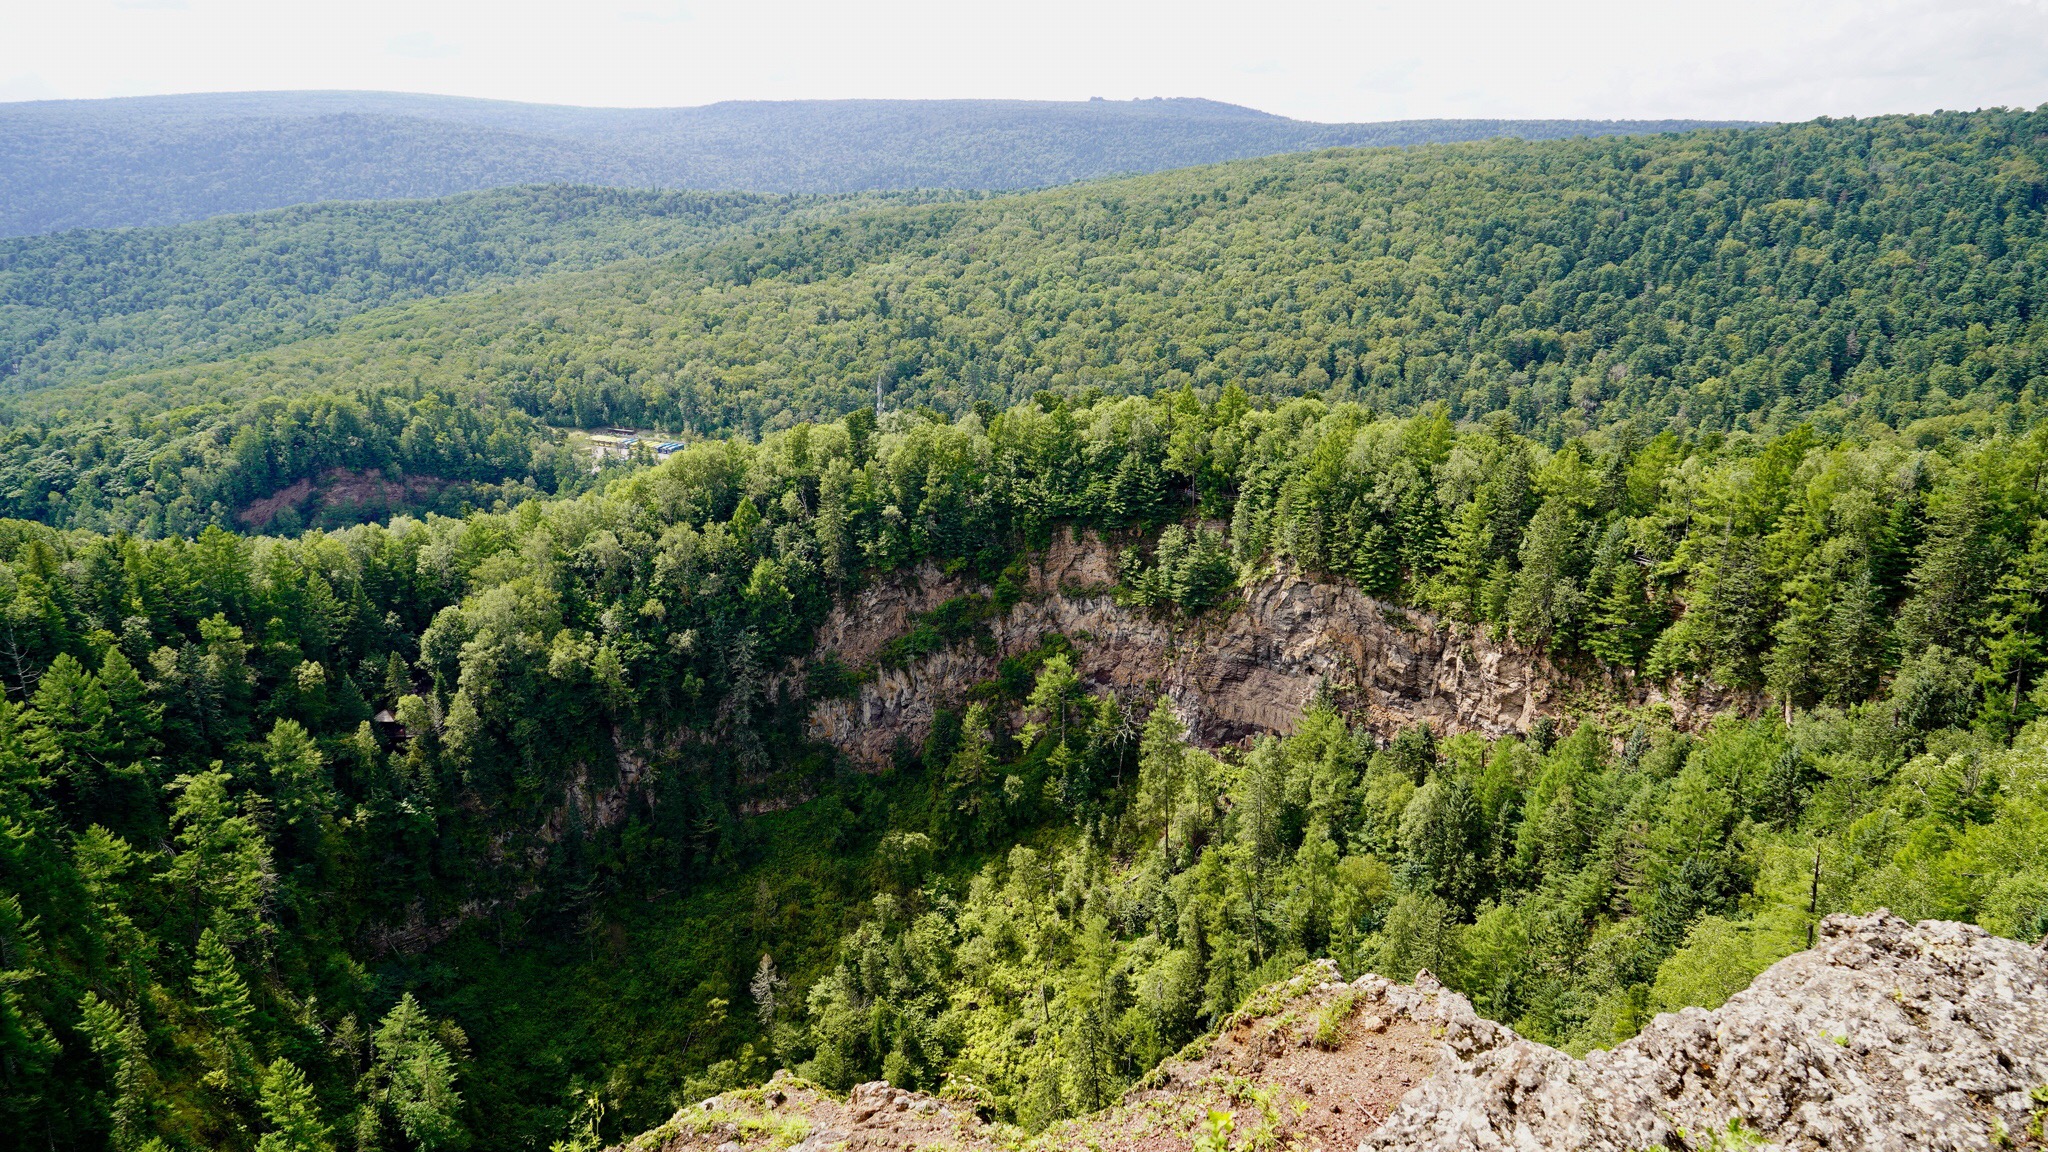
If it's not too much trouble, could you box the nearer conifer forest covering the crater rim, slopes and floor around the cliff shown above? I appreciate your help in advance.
[0,387,2048,1148]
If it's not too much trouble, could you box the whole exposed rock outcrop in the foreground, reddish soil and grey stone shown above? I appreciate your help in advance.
[606,912,2048,1152]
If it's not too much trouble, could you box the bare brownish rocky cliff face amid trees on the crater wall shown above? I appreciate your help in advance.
[811,535,1747,767]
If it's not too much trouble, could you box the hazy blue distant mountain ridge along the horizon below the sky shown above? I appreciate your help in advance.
[0,92,1761,236]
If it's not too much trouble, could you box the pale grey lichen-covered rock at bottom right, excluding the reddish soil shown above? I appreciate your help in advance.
[1360,910,2048,1152]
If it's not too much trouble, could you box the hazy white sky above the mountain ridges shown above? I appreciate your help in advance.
[0,0,2048,121]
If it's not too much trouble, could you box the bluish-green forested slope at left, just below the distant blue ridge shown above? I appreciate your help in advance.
[0,187,930,392]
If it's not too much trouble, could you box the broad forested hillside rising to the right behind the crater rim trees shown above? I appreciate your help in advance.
[0,111,2048,533]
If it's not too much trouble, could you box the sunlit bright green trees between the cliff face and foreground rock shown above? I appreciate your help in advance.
[786,688,2048,1129]
